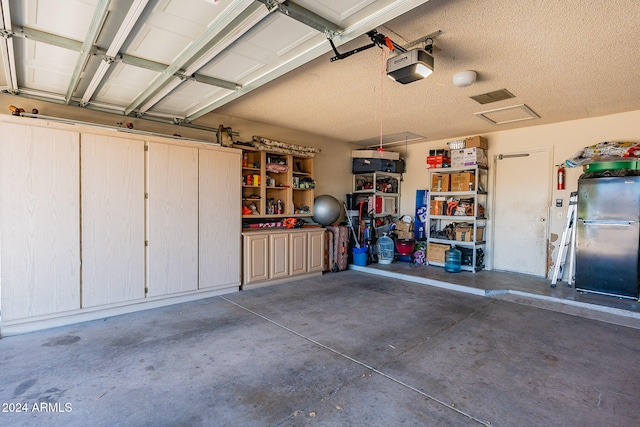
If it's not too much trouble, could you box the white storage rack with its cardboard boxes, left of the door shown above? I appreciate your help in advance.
[427,166,488,272]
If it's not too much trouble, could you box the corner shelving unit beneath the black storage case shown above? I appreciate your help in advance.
[353,172,401,217]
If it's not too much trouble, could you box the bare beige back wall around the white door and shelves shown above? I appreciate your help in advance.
[392,111,640,276]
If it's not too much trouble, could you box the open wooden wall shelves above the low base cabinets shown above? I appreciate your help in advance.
[238,147,315,218]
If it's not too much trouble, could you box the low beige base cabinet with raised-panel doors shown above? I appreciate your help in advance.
[242,228,325,289]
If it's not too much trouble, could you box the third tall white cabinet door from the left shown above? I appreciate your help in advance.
[147,143,198,296]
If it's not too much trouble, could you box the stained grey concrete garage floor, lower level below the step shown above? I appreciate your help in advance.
[0,266,640,426]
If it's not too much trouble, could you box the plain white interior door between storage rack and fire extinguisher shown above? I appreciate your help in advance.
[491,149,553,277]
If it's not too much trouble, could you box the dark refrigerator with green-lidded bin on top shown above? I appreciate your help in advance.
[575,170,640,299]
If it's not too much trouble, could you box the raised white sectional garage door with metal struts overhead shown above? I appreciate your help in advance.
[0,0,427,123]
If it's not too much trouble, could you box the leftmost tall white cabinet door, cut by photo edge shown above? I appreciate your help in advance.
[0,123,80,321]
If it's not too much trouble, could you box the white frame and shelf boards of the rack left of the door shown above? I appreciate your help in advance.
[427,165,488,272]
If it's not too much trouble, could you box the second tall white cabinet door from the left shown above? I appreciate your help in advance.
[81,134,145,307]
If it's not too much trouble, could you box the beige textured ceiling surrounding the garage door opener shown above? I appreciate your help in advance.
[217,0,640,145]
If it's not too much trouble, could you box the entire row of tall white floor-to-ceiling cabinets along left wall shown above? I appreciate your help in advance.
[0,116,242,335]
